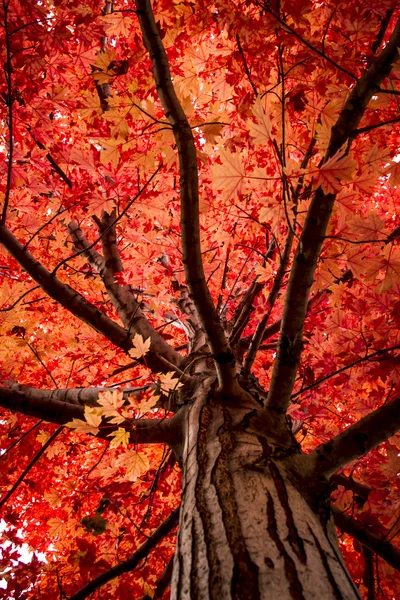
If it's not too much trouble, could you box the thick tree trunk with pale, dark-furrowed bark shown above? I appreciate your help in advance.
[171,390,360,600]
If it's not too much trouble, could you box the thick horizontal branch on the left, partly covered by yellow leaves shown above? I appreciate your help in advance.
[0,384,180,446]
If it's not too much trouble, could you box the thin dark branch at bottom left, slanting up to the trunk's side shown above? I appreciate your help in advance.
[69,508,179,600]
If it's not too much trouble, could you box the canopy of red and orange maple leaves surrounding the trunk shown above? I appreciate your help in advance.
[0,0,400,600]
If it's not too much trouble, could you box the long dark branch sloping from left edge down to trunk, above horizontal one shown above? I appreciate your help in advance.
[0,225,179,372]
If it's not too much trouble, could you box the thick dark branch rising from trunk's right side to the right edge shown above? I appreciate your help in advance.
[304,397,400,477]
